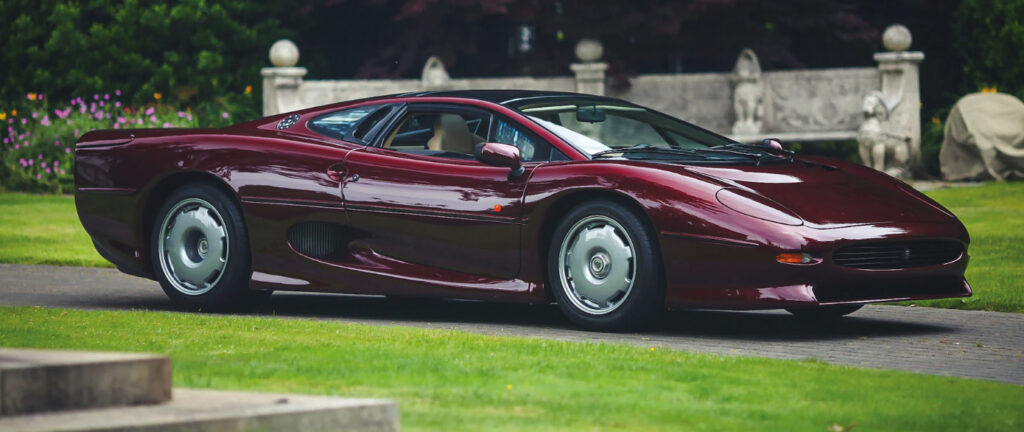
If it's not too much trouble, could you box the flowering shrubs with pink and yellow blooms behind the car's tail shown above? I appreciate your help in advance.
[0,90,234,193]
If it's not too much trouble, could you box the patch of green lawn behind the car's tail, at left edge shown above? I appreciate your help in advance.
[0,193,112,267]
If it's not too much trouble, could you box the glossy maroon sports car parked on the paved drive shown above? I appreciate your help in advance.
[75,90,971,330]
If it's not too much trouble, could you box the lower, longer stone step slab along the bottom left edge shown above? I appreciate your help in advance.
[0,389,398,432]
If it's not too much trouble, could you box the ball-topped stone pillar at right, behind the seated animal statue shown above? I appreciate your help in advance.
[874,25,925,173]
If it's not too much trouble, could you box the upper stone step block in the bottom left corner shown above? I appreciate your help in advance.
[0,348,171,415]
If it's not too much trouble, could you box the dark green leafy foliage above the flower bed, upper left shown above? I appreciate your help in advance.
[0,0,293,103]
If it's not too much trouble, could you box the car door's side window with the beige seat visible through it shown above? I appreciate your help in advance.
[382,111,490,159]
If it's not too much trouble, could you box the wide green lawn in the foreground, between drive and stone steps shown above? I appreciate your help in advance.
[0,307,1024,431]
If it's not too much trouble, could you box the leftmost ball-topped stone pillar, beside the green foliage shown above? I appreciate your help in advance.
[260,39,307,116]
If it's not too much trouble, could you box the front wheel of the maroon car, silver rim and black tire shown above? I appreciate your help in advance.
[548,200,665,331]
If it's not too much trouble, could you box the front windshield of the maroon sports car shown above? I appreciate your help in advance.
[519,99,788,165]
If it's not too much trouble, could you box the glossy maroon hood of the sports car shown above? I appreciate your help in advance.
[667,161,954,228]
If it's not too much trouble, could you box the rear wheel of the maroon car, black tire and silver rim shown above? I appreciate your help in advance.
[150,183,272,311]
